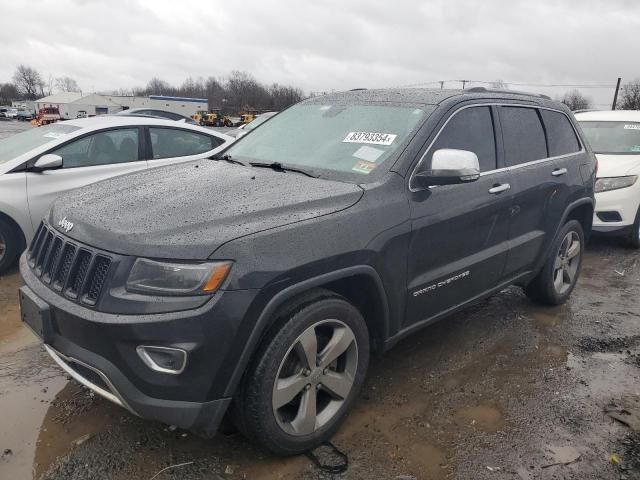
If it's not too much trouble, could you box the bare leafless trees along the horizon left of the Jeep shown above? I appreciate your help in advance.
[0,65,305,112]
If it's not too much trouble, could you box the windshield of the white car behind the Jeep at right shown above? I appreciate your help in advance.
[580,122,640,155]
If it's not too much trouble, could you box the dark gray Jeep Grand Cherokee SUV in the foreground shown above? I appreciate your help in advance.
[20,89,596,455]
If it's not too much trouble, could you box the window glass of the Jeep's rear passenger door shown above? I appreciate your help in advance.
[500,107,548,166]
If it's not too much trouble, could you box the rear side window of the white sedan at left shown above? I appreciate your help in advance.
[149,127,222,160]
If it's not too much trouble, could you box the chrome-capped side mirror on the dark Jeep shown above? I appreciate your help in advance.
[413,148,480,188]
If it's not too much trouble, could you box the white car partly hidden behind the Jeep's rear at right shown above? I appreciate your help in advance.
[576,110,640,248]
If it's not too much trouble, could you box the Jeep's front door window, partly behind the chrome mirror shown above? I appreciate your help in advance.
[431,107,497,172]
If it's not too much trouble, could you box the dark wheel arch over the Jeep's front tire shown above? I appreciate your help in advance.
[225,265,389,396]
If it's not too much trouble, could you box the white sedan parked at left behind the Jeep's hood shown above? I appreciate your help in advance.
[0,116,233,273]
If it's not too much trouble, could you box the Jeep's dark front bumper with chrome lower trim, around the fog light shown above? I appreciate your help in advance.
[20,255,256,435]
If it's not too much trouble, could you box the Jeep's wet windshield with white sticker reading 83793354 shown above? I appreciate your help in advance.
[225,104,426,178]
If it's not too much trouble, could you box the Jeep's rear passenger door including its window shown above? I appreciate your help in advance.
[499,105,564,278]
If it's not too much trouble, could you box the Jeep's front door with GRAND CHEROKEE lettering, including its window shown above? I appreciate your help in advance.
[406,105,513,324]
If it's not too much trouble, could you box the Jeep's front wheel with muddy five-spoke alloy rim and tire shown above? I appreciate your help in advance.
[235,290,369,455]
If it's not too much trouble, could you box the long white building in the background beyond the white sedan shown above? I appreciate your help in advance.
[35,92,209,119]
